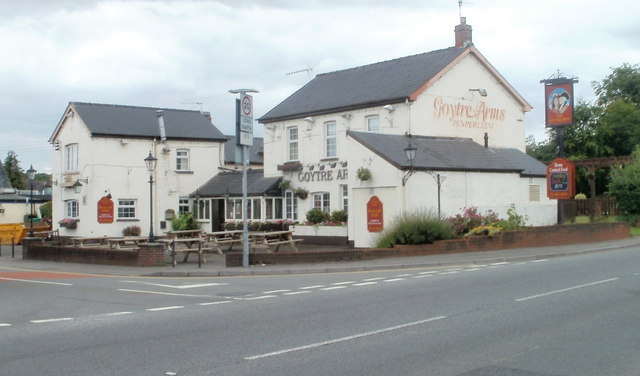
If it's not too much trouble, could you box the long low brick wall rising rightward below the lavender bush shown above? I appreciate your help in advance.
[226,222,631,267]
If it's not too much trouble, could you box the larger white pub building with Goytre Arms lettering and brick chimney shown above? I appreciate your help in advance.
[259,18,556,247]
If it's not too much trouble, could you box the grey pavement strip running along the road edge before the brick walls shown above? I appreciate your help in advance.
[0,237,640,277]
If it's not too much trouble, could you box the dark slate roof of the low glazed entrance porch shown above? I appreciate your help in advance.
[191,170,282,197]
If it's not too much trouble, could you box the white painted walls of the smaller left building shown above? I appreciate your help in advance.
[53,110,223,236]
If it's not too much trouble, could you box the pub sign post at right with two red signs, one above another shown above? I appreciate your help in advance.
[540,73,578,223]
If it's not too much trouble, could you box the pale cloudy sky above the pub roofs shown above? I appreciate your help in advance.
[0,0,640,173]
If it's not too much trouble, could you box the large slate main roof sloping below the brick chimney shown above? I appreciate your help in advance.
[258,47,465,123]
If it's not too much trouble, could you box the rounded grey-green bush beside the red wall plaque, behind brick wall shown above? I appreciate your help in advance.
[375,210,455,248]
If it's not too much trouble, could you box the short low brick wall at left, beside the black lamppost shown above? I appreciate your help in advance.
[22,238,165,266]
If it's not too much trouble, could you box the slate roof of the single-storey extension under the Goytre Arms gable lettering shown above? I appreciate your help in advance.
[347,131,546,177]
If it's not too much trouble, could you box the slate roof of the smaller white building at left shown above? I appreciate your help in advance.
[49,102,227,142]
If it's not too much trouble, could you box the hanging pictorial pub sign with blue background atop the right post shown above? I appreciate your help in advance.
[541,78,576,127]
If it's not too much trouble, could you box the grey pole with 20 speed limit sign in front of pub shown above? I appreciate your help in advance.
[229,89,259,267]
